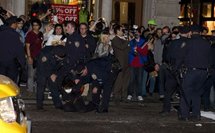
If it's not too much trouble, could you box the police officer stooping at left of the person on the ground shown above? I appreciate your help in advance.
[36,46,65,110]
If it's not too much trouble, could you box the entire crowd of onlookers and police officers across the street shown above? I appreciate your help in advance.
[0,5,215,121]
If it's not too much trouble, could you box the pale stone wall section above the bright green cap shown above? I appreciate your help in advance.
[143,0,180,27]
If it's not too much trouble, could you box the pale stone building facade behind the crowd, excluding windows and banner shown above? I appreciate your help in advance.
[0,0,180,27]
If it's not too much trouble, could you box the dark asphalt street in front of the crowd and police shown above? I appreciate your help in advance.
[21,90,215,133]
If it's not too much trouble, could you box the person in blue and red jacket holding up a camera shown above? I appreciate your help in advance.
[127,27,148,102]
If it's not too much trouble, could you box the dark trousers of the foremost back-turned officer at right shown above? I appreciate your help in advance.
[180,70,207,118]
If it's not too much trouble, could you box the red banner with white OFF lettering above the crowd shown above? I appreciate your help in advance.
[51,4,78,23]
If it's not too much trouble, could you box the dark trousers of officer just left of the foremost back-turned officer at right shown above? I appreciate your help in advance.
[163,71,178,112]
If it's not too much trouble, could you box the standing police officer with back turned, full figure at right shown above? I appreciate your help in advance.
[179,25,210,121]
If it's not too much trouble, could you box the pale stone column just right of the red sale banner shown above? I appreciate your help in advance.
[101,0,112,23]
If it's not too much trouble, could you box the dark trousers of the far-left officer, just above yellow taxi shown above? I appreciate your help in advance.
[0,61,19,83]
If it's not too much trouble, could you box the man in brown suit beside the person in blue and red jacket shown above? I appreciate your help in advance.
[112,25,130,102]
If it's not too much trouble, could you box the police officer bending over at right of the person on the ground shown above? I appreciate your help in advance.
[72,57,113,113]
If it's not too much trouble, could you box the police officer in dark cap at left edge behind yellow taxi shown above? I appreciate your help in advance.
[0,16,25,82]
